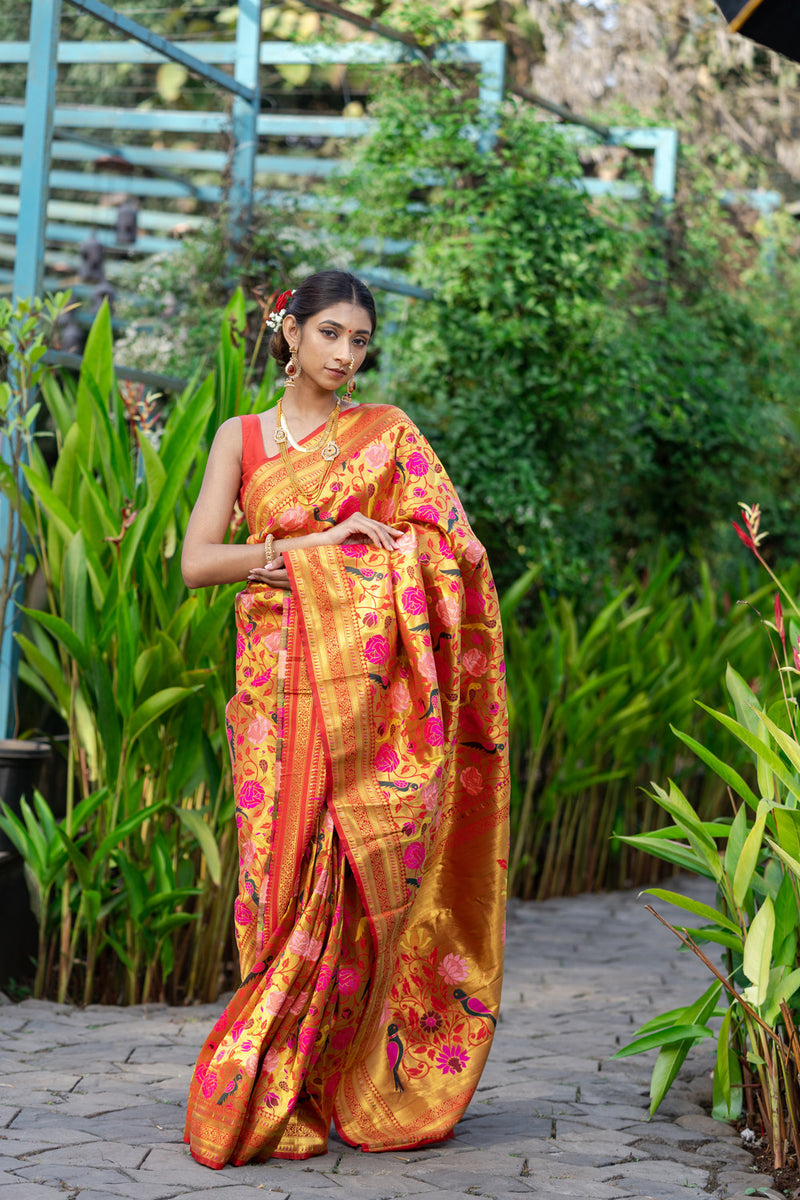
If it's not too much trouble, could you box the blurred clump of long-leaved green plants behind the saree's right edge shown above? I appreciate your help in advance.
[501,546,769,899]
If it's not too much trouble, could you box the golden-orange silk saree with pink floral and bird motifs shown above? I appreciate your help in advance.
[185,404,509,1168]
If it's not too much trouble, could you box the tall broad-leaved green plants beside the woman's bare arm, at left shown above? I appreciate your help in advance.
[0,285,270,1002]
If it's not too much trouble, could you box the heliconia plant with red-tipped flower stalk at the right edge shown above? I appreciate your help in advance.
[619,505,800,1170]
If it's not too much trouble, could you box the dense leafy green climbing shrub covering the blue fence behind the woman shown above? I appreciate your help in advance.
[323,66,798,597]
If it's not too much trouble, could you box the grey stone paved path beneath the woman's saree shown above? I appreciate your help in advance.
[0,882,780,1200]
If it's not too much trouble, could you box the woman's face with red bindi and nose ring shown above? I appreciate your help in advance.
[283,301,372,391]
